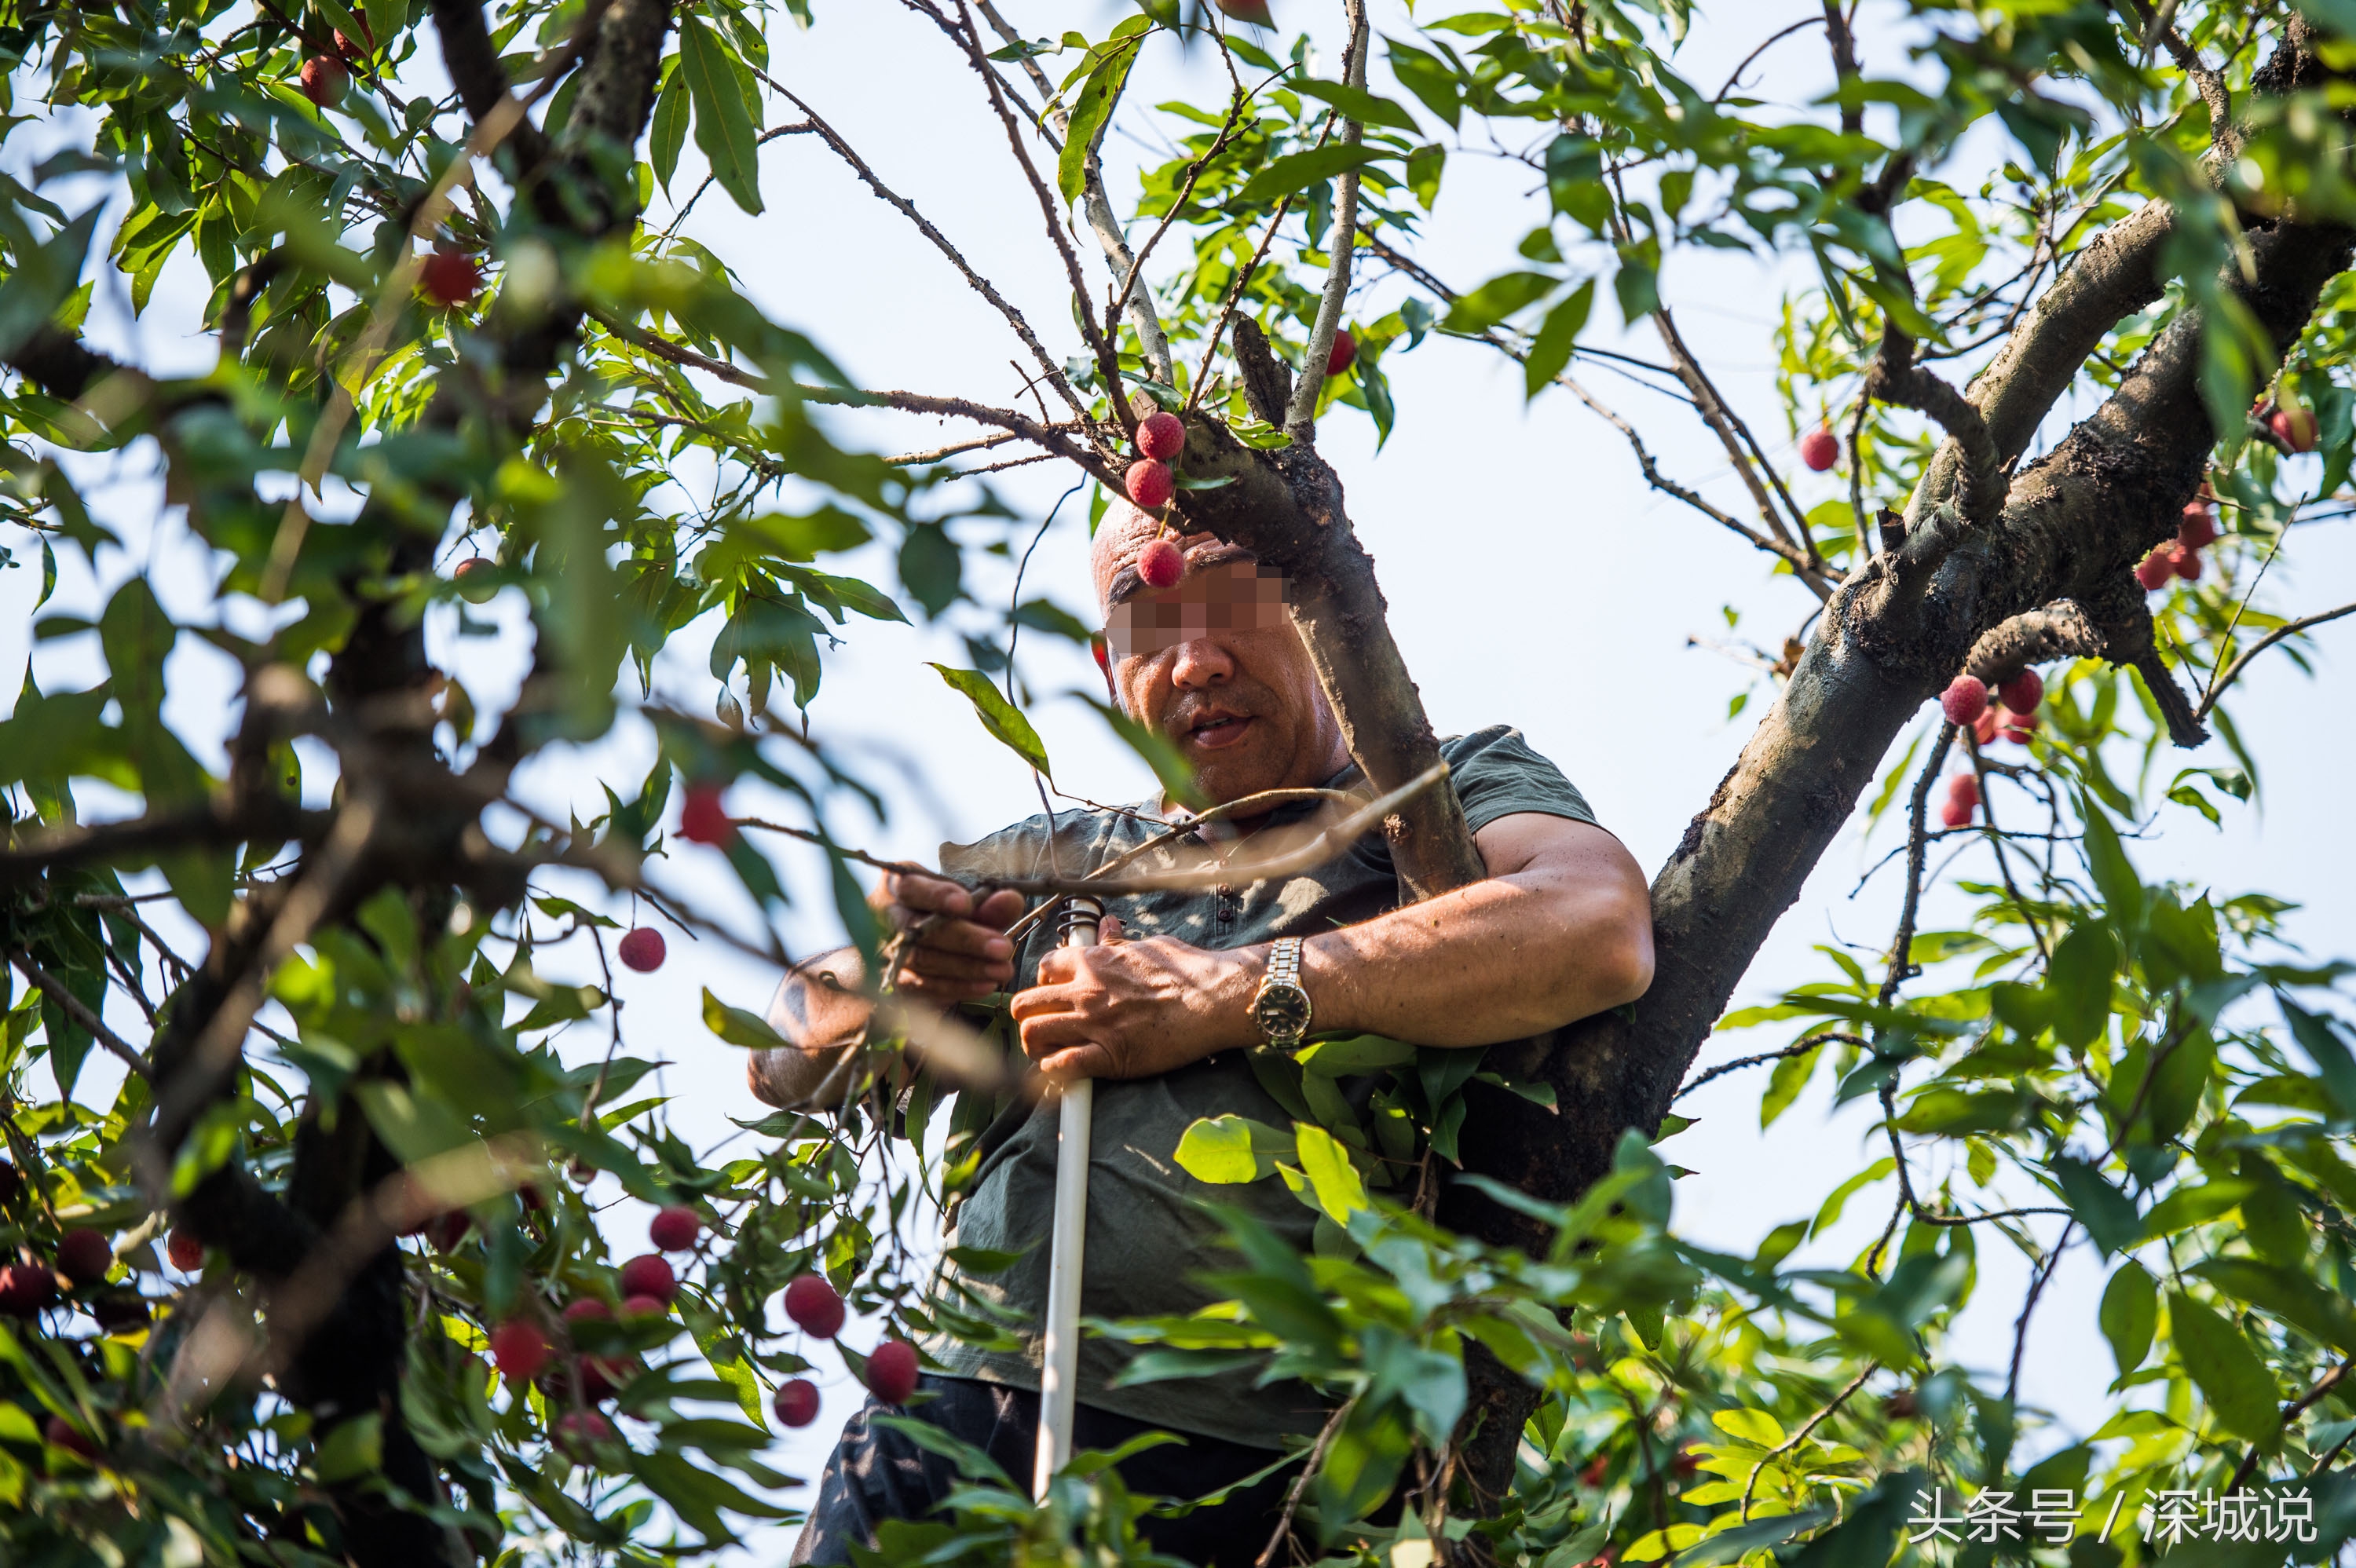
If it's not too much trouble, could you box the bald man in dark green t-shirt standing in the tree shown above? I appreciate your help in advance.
[749,506,1652,1563]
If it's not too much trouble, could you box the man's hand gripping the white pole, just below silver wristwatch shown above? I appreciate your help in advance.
[1013,918,1265,1078]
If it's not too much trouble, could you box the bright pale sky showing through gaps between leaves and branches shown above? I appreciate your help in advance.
[0,0,2356,1561]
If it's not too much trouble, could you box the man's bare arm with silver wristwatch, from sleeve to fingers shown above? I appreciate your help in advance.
[1013,812,1652,1078]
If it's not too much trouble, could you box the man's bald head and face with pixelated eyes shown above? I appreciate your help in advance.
[1096,514,1350,800]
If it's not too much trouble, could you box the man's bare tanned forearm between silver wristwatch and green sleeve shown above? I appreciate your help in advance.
[1301,824,1652,1045]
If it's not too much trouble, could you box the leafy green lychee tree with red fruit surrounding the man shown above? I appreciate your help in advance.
[0,0,2356,1568]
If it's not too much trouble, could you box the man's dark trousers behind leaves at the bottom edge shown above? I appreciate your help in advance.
[792,1377,1296,1568]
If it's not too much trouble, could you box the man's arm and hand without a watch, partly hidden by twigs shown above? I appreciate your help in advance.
[744,873,1023,1109]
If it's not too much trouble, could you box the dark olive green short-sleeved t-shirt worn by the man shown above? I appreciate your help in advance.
[924,726,1595,1448]
